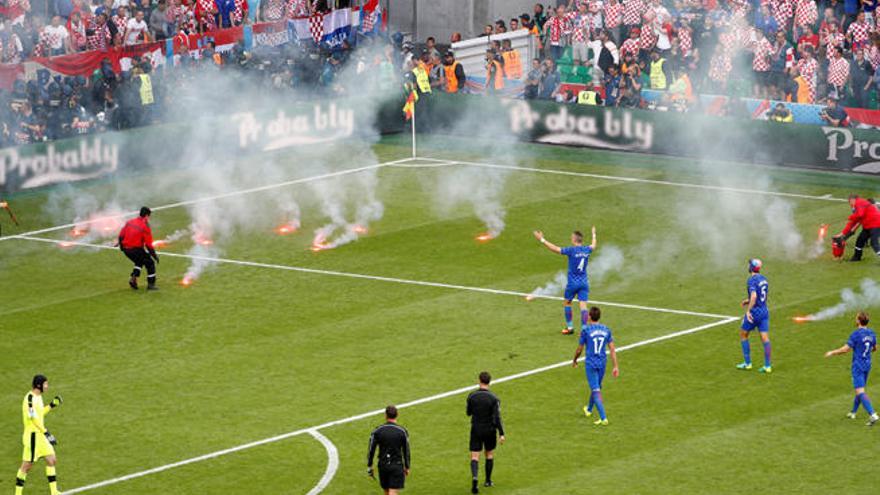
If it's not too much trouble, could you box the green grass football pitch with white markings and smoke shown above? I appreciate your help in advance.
[0,136,880,495]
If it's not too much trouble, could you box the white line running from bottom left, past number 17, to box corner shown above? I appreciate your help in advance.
[63,317,739,495]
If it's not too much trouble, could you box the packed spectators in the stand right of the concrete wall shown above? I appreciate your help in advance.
[474,0,880,121]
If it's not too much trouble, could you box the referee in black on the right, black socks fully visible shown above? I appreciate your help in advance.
[467,371,504,493]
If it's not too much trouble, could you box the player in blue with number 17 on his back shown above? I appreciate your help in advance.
[571,306,620,426]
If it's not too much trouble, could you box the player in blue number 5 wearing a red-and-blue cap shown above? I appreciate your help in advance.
[736,258,773,373]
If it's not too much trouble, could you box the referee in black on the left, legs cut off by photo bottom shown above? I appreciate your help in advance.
[367,406,409,495]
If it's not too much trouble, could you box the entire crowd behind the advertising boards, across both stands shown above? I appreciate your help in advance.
[0,0,880,146]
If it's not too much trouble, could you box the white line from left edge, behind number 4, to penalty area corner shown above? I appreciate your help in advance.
[17,235,734,318]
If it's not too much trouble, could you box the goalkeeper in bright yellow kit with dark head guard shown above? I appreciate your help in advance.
[15,375,61,495]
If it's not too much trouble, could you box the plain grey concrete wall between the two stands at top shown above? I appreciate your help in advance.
[388,0,555,44]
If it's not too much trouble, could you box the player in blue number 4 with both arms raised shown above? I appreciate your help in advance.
[535,227,596,335]
